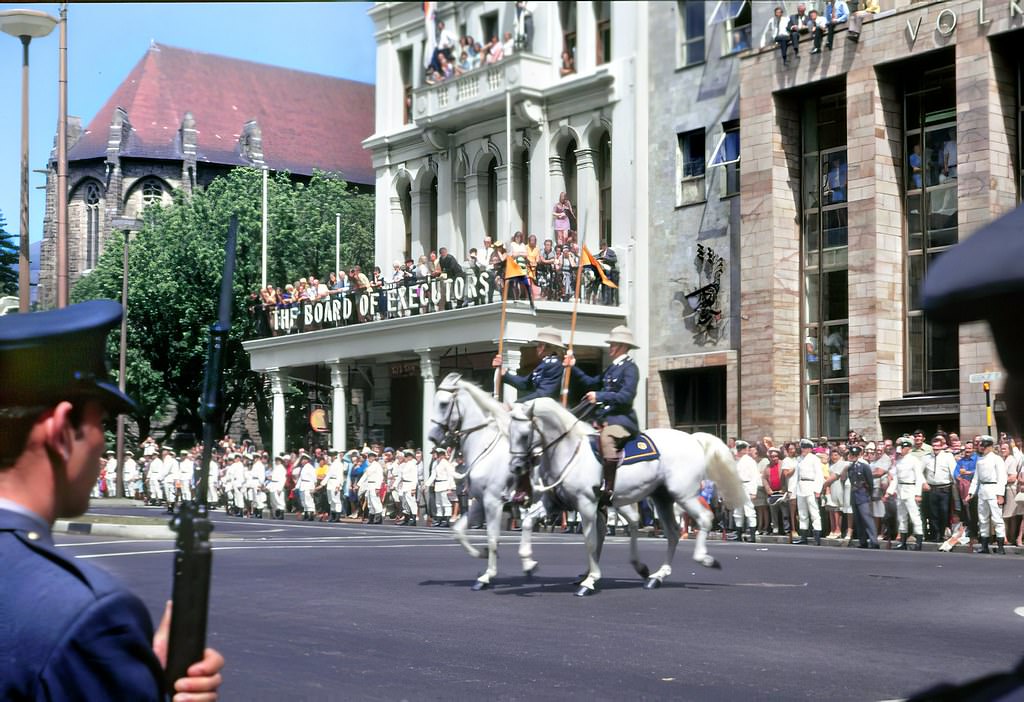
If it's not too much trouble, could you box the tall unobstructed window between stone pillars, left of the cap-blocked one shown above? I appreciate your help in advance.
[801,88,850,438]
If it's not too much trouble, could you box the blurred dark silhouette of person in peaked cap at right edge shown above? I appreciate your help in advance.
[912,202,1024,702]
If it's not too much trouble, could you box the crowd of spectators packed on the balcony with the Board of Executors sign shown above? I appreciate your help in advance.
[249,225,618,337]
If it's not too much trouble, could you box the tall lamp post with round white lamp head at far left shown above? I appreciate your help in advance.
[0,9,57,312]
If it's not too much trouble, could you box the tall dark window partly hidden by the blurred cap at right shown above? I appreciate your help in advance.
[903,64,959,393]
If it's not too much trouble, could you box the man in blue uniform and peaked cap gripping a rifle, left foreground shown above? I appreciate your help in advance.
[0,300,224,700]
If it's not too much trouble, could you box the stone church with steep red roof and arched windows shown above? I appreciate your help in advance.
[38,44,374,307]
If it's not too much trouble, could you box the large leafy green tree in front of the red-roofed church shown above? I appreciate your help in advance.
[73,168,374,446]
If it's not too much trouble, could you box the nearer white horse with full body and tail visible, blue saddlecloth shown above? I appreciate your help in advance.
[509,398,745,597]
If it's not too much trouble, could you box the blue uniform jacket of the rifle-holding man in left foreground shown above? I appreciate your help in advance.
[0,509,165,700]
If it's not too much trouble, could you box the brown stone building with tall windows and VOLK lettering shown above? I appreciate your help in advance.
[738,0,1024,438]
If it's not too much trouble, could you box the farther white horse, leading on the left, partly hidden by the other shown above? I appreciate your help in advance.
[427,372,537,590]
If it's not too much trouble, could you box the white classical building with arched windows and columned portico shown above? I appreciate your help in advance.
[246,2,649,451]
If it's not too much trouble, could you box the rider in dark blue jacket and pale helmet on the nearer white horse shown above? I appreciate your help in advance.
[566,326,640,504]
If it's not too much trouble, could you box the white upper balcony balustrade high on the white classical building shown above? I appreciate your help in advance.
[413,53,558,126]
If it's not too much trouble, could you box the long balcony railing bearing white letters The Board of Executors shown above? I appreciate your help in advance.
[250,267,620,338]
